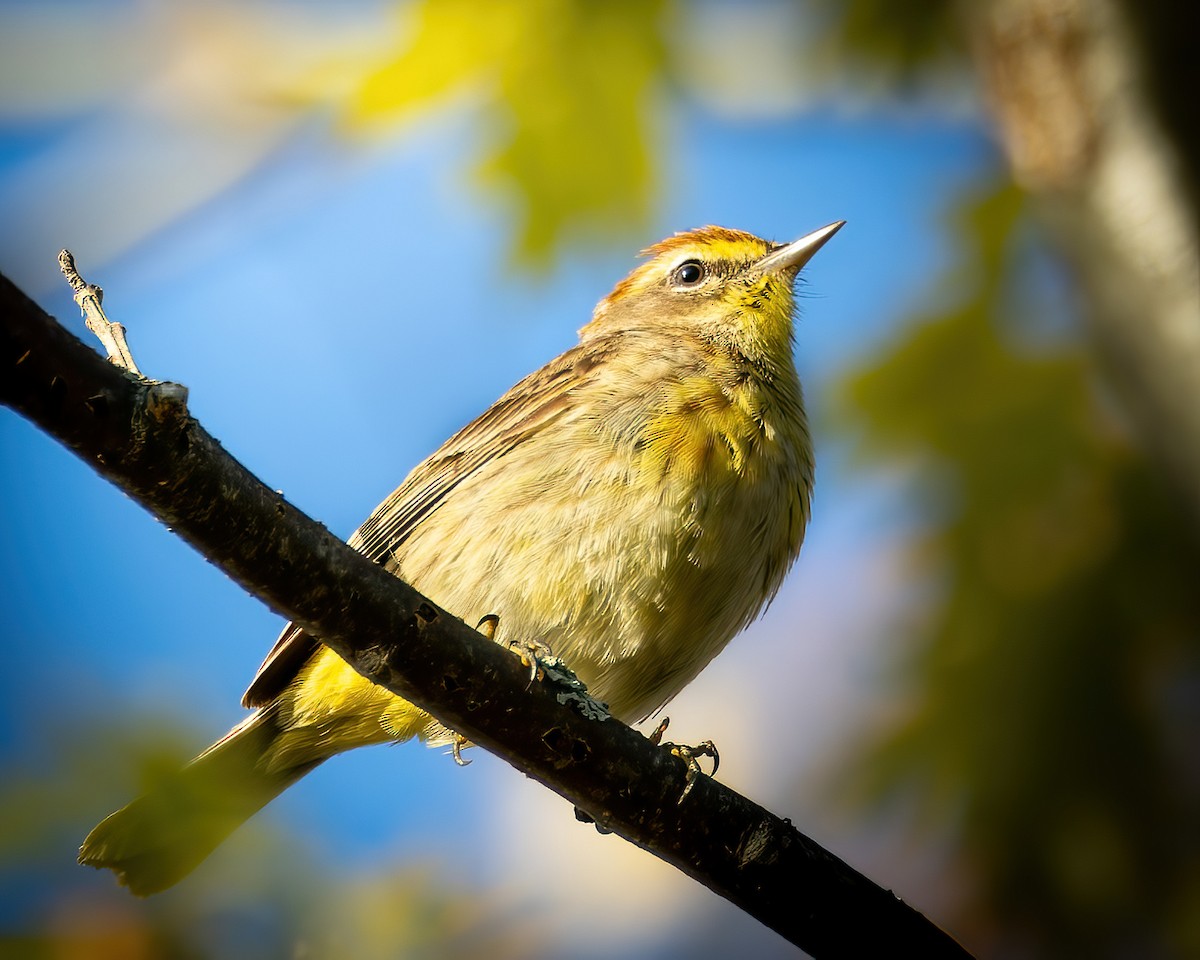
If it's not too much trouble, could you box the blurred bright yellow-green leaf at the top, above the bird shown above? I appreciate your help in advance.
[349,0,664,263]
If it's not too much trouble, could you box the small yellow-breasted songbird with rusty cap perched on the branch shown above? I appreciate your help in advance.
[79,221,842,894]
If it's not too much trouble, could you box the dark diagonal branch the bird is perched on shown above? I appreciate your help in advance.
[0,276,968,958]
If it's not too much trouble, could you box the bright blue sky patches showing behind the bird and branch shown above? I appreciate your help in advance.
[0,4,992,942]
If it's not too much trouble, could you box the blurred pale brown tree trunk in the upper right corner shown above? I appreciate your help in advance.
[960,0,1200,522]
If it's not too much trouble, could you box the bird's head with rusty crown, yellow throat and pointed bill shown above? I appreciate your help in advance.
[580,221,845,362]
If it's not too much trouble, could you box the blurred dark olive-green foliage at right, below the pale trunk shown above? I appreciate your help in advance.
[838,177,1200,956]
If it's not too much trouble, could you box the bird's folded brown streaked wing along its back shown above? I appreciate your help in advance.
[241,341,612,707]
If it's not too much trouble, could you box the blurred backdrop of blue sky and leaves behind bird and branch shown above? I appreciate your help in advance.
[0,0,1200,960]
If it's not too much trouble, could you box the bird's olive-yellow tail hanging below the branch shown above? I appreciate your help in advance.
[79,708,323,896]
